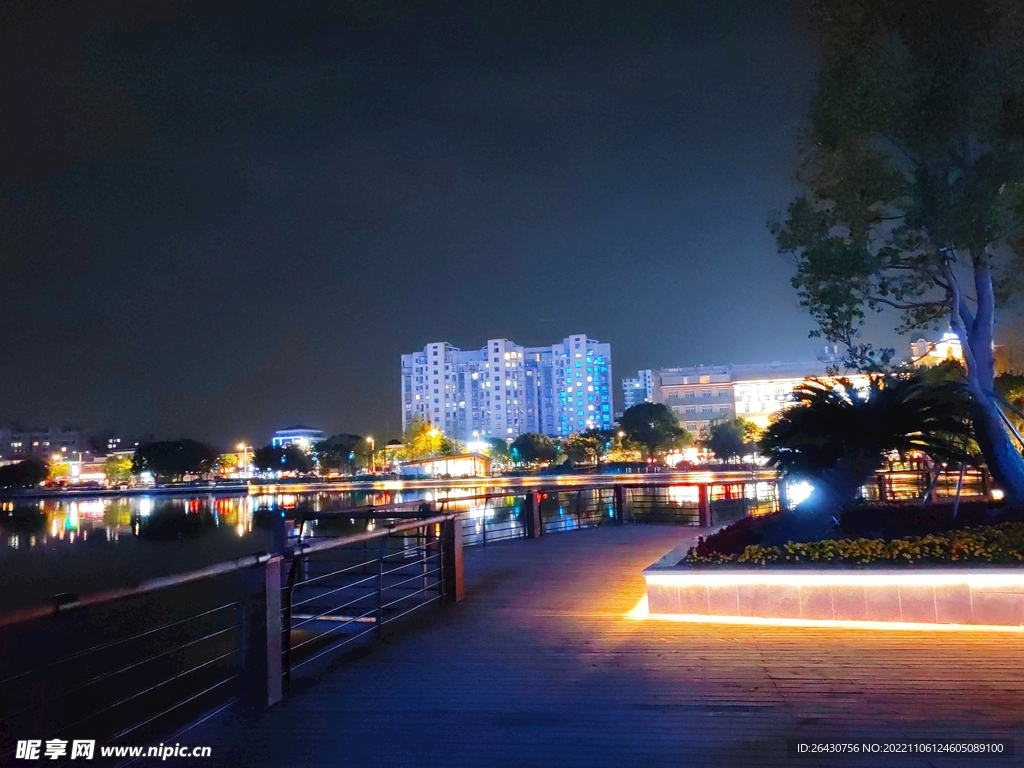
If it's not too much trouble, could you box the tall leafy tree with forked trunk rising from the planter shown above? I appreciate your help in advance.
[772,0,1024,502]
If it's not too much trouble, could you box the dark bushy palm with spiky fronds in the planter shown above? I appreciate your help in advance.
[760,373,972,540]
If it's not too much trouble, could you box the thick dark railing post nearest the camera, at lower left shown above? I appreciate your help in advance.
[242,555,283,708]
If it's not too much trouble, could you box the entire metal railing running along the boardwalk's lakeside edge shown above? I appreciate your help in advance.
[0,473,774,765]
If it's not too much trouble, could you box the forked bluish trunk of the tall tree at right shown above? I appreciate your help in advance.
[946,259,1024,504]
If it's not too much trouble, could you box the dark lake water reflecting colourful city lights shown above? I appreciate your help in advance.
[0,478,773,611]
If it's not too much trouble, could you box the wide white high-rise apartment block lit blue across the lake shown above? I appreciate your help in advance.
[401,334,612,440]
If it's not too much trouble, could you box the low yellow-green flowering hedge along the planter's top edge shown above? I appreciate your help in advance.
[684,522,1024,565]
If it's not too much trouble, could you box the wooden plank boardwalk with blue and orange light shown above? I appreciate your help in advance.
[188,525,1024,768]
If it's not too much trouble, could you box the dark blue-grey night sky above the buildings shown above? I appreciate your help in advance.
[0,0,817,444]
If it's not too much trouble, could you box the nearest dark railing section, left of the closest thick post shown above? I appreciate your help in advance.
[0,555,280,765]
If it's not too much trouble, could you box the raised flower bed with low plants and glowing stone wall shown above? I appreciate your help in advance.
[644,508,1024,629]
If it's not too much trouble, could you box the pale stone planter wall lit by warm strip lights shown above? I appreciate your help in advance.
[644,567,1024,627]
